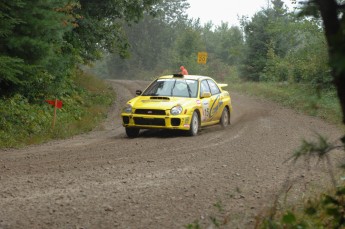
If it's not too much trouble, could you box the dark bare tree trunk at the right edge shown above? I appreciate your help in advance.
[317,0,345,124]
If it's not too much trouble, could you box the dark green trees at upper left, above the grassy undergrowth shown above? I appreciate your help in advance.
[0,0,159,97]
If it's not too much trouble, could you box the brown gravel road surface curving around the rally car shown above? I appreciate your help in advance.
[0,80,341,229]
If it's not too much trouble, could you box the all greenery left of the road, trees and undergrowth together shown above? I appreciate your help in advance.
[0,0,157,147]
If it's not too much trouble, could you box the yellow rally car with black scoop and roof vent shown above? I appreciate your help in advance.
[121,74,232,138]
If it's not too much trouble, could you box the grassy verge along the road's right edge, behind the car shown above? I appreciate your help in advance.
[228,80,341,127]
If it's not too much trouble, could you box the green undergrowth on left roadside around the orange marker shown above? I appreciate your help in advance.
[0,71,115,148]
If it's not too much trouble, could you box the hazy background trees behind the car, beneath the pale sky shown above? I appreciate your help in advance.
[87,0,331,91]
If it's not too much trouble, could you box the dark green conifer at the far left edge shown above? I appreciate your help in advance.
[0,0,73,98]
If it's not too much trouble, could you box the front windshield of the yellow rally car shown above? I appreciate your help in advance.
[143,79,198,98]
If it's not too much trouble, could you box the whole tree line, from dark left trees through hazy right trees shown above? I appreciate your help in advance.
[0,0,331,93]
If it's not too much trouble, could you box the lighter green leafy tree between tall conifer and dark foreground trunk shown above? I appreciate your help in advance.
[260,17,331,85]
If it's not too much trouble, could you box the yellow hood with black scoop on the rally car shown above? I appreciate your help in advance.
[128,96,197,110]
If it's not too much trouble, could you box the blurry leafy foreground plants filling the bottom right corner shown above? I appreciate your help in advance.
[256,186,345,229]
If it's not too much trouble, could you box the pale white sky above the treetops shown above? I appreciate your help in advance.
[187,0,293,26]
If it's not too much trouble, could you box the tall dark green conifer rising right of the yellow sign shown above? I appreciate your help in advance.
[241,0,291,81]
